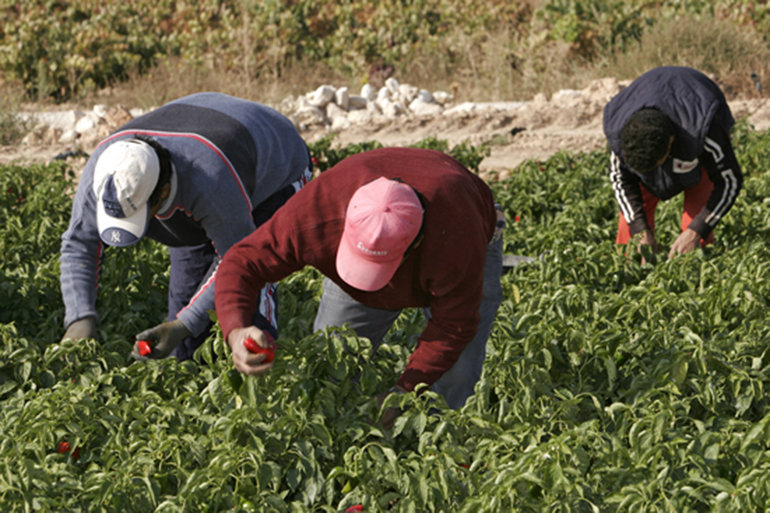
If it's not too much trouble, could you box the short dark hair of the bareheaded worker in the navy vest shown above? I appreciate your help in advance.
[620,109,674,173]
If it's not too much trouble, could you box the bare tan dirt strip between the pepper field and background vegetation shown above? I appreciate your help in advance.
[0,87,770,183]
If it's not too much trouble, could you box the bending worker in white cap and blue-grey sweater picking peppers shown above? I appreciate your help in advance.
[60,93,311,360]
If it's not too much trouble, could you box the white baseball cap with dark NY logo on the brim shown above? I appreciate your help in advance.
[93,139,160,247]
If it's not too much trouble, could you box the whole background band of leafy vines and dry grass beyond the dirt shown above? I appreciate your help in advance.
[0,0,770,107]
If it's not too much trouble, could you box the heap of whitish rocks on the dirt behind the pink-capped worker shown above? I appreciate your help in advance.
[280,78,454,132]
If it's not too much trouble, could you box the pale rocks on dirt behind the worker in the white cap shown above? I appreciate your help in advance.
[20,105,144,146]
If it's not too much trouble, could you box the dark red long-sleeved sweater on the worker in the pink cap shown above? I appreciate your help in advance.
[216,148,496,390]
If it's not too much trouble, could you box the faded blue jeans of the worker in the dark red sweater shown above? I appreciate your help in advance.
[313,216,503,409]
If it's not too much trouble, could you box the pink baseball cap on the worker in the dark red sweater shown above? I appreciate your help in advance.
[337,178,423,292]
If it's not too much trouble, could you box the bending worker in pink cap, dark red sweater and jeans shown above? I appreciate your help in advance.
[216,148,505,408]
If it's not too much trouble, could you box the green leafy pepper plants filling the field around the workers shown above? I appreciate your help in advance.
[0,124,770,512]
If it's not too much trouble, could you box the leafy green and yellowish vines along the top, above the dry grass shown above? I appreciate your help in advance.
[6,0,770,99]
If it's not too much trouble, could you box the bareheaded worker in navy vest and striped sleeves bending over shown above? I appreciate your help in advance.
[604,67,743,258]
